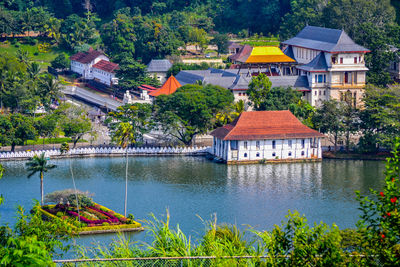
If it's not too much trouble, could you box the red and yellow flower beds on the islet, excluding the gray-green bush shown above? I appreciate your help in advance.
[40,203,141,233]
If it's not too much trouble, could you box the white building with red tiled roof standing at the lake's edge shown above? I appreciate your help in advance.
[211,110,324,164]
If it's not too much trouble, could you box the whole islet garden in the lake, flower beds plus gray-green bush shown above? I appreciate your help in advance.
[39,189,142,234]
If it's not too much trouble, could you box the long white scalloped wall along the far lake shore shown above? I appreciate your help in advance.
[0,147,210,161]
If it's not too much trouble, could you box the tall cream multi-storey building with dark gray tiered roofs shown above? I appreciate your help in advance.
[282,26,369,106]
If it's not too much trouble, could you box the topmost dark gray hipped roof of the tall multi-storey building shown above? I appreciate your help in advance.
[282,26,369,52]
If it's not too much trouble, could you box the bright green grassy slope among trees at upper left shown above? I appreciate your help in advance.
[0,42,66,68]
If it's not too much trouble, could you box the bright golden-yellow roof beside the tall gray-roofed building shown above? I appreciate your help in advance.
[244,46,296,63]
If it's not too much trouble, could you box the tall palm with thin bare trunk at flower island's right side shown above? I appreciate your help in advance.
[113,122,136,217]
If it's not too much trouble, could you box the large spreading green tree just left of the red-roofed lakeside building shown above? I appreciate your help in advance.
[155,85,233,145]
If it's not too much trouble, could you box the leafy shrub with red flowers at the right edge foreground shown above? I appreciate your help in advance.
[356,138,400,266]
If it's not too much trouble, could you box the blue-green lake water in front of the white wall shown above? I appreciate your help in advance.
[0,157,384,255]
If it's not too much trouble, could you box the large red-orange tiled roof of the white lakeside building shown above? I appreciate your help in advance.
[211,110,324,140]
